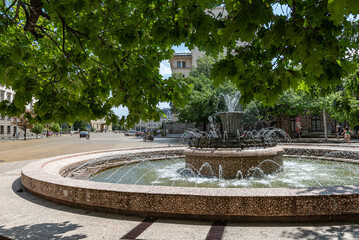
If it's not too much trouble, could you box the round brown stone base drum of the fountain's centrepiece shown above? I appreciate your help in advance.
[184,146,284,179]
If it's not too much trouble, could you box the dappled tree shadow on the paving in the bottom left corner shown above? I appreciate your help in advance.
[0,221,87,240]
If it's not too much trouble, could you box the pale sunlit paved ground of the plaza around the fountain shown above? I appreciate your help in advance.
[0,135,359,240]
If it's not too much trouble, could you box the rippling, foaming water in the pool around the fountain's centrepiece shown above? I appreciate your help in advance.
[90,158,359,188]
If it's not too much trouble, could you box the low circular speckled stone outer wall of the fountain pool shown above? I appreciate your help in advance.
[21,147,359,222]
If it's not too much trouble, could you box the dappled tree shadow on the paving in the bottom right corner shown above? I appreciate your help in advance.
[282,225,359,240]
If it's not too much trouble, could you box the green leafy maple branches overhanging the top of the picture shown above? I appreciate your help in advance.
[0,0,359,125]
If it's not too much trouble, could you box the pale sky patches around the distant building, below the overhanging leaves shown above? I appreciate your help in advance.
[112,44,190,118]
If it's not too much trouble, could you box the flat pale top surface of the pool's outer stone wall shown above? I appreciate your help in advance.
[21,144,359,197]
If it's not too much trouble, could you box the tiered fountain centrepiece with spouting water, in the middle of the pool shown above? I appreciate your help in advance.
[184,92,284,179]
